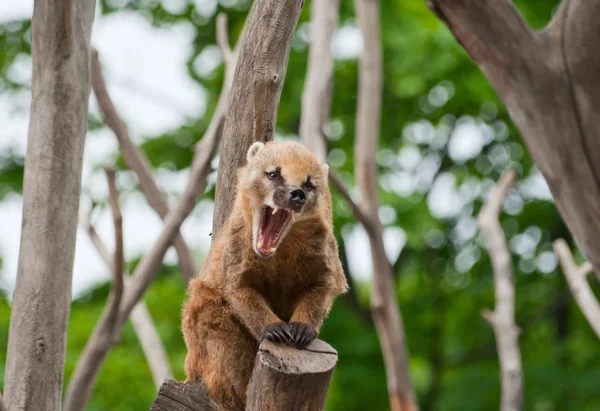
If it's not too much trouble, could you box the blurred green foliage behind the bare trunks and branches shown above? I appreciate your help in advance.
[0,0,600,411]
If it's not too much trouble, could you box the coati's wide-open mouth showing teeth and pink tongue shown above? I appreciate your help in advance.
[256,206,293,257]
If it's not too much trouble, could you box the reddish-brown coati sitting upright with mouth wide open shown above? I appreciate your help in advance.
[182,141,348,410]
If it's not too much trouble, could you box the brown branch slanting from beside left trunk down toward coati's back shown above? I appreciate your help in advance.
[92,50,198,280]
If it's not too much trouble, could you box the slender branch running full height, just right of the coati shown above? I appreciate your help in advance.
[354,0,418,411]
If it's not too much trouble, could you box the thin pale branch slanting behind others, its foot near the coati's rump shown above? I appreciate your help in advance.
[81,208,173,389]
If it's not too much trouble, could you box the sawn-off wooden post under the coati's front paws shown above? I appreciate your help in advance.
[246,340,337,411]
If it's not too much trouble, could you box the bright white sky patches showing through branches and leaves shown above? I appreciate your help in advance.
[0,0,549,297]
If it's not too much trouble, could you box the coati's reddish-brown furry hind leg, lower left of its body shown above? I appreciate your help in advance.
[183,282,258,410]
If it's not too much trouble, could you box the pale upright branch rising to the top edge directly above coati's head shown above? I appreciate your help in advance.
[300,0,340,162]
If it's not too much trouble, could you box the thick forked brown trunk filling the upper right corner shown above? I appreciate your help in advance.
[428,0,600,275]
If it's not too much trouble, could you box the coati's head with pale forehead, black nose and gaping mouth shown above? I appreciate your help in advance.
[239,142,329,257]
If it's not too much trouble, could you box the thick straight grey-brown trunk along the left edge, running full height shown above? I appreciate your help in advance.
[5,0,95,411]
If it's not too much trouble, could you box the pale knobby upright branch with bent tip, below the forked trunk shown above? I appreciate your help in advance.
[477,169,523,411]
